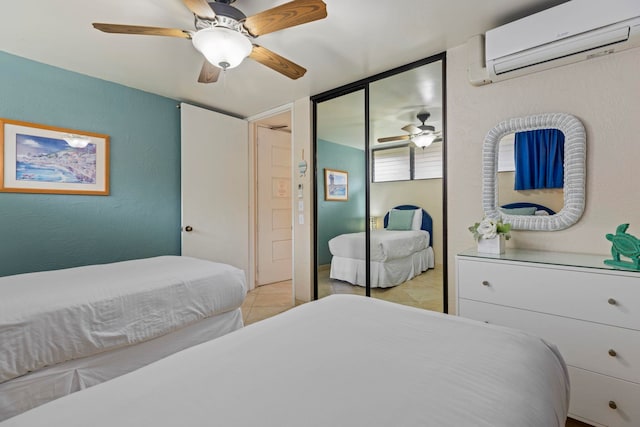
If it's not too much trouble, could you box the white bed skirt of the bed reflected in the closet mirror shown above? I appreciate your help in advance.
[329,247,435,288]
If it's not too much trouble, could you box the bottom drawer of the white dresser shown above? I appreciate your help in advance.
[569,367,640,427]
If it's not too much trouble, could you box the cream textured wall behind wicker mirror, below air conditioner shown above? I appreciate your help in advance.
[447,45,640,313]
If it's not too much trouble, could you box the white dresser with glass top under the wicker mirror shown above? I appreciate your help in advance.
[456,250,640,427]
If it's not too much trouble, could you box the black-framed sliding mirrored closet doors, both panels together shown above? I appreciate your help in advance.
[312,54,447,312]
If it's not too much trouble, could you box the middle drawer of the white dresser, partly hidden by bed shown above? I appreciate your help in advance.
[458,299,640,384]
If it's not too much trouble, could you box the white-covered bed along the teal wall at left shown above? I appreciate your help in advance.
[0,256,246,420]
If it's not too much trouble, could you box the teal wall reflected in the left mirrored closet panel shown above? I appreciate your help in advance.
[316,139,367,265]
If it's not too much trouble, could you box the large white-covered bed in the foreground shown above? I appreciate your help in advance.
[0,295,569,427]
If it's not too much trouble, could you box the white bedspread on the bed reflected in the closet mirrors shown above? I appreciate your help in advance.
[329,230,429,262]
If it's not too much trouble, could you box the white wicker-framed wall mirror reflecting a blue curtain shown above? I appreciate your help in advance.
[482,113,586,231]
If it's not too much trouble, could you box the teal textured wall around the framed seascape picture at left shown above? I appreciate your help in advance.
[0,51,180,276]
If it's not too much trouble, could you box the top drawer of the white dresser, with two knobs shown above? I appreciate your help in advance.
[457,257,640,330]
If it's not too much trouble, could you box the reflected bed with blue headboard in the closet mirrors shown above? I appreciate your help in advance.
[329,205,435,288]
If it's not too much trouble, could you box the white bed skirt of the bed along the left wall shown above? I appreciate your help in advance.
[0,308,243,421]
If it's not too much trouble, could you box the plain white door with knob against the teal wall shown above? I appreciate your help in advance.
[181,104,249,277]
